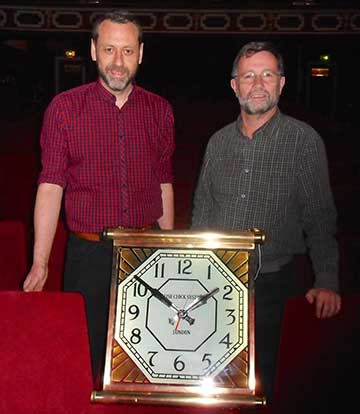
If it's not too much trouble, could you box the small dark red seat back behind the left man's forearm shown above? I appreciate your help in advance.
[0,220,27,290]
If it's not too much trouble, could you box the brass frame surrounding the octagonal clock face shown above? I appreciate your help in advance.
[91,228,266,408]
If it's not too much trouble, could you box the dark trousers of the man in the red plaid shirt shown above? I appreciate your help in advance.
[64,233,112,379]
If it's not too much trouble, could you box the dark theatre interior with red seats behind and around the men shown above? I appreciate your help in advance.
[0,0,360,414]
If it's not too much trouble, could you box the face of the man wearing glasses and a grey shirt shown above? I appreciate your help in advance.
[231,51,285,115]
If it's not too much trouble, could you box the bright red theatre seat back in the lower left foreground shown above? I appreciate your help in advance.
[0,292,92,414]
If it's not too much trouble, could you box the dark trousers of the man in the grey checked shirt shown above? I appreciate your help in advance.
[255,262,302,403]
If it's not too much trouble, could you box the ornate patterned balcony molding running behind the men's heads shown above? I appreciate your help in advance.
[0,5,360,35]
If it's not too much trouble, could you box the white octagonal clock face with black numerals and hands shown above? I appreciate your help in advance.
[114,249,248,384]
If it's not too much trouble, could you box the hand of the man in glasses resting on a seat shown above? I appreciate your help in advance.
[305,288,341,319]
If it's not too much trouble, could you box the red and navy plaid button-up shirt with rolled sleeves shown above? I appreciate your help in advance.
[38,81,174,232]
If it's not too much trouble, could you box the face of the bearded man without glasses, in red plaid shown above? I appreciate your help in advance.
[91,20,143,92]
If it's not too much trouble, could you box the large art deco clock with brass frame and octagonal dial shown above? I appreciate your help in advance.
[92,229,265,407]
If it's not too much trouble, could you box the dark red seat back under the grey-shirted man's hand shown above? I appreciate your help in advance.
[273,295,360,414]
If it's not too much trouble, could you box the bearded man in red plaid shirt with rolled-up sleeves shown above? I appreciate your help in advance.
[24,12,174,376]
